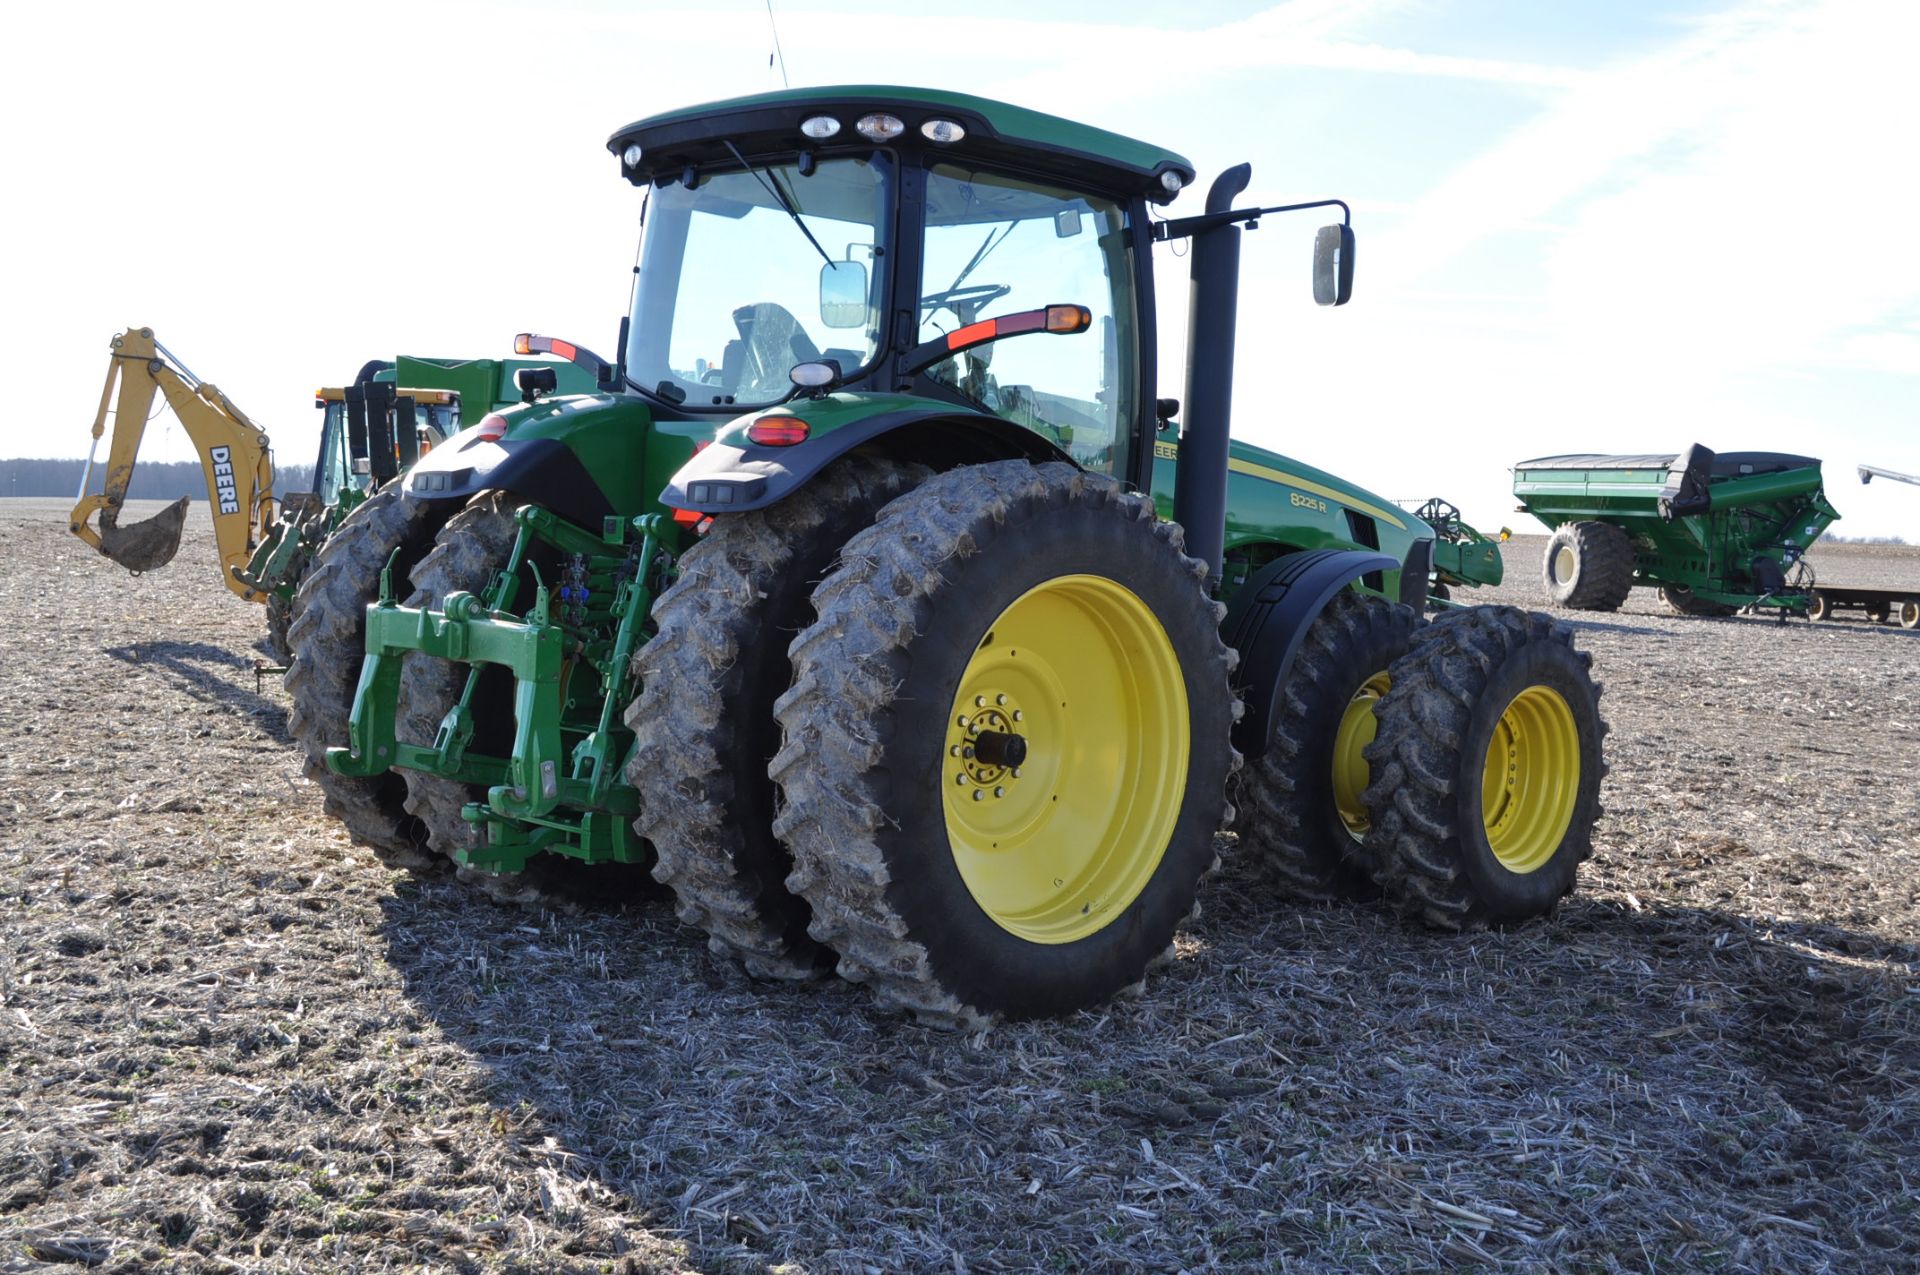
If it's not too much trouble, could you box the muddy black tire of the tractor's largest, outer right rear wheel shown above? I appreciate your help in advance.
[770,461,1236,1025]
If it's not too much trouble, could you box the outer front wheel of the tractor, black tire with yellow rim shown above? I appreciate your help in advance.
[1365,607,1607,929]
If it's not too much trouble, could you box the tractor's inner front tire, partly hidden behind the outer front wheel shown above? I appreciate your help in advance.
[1233,589,1419,902]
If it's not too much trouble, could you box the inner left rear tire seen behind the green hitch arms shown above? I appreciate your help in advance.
[394,492,520,876]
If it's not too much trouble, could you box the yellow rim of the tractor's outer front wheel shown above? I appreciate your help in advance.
[1480,686,1580,872]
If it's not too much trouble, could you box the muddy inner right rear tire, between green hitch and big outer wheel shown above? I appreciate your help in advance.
[626,457,927,979]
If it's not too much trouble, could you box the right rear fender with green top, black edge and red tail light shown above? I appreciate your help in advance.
[660,396,1073,515]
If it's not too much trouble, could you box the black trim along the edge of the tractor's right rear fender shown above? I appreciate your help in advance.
[660,401,1075,515]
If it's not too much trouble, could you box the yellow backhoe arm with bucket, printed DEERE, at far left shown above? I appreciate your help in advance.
[69,328,275,601]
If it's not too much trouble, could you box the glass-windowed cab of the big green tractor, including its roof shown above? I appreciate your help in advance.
[609,88,1192,489]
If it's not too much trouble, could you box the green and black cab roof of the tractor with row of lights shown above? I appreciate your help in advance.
[607,84,1194,204]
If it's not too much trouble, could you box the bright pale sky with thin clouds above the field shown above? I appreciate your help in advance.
[0,0,1920,541]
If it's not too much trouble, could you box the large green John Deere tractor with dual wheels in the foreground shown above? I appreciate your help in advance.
[311,86,1601,1023]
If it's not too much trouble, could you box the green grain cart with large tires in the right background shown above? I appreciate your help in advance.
[1513,444,1839,618]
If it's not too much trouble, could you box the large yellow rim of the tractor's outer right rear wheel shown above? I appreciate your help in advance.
[941,576,1188,943]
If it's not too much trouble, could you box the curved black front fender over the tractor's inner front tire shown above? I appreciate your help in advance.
[1221,549,1397,760]
